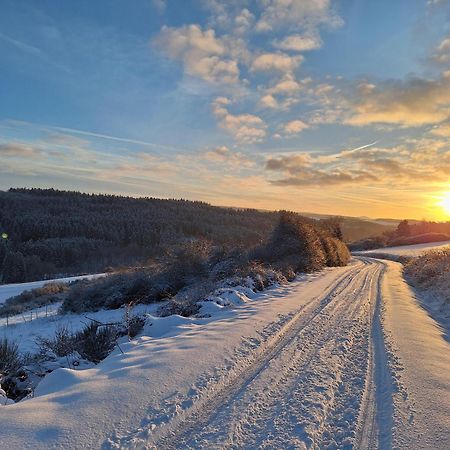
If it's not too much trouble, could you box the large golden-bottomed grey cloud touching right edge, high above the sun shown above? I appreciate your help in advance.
[345,76,450,127]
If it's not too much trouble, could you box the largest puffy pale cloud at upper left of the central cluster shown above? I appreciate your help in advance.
[152,25,239,84]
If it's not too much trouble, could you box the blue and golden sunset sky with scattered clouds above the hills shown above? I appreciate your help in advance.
[0,0,450,220]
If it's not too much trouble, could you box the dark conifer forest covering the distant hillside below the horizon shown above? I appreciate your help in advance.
[0,189,392,283]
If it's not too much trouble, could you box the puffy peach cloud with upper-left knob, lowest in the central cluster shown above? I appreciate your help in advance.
[212,97,267,144]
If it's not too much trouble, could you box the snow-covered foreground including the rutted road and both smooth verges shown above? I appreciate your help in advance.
[0,257,450,449]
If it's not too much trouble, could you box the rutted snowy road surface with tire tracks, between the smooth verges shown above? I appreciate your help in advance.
[148,259,392,449]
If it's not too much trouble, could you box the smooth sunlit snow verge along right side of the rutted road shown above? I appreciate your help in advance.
[382,261,450,449]
